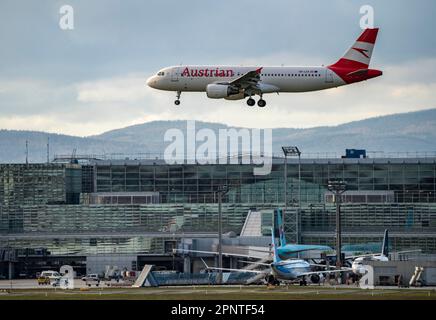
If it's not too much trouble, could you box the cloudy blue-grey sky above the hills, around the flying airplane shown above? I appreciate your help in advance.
[0,0,436,136]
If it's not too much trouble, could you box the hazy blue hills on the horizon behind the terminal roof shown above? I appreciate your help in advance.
[0,109,436,163]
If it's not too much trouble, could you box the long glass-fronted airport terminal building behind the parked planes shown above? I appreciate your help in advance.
[0,157,436,277]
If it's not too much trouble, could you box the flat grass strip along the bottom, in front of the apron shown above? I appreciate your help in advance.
[0,286,436,300]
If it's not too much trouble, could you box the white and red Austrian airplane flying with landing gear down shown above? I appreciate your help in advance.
[147,28,383,107]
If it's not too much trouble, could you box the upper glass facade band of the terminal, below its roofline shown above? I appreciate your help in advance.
[95,159,436,203]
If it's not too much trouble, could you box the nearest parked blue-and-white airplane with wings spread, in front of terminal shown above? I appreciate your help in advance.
[203,228,349,285]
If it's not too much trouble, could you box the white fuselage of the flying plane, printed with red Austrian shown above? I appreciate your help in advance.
[147,65,346,93]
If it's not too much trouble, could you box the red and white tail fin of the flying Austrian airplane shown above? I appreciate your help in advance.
[329,28,378,72]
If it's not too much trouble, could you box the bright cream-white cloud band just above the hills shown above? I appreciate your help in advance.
[0,57,436,136]
